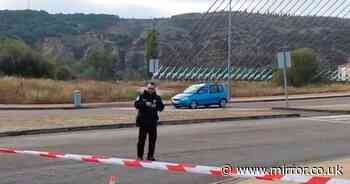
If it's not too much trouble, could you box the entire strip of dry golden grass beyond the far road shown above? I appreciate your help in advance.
[0,77,350,104]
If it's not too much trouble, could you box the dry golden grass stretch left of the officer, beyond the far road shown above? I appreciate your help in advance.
[0,78,138,104]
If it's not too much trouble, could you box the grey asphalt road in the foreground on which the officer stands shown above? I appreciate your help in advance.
[0,117,350,184]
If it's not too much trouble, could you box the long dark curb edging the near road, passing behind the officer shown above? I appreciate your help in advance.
[0,114,300,137]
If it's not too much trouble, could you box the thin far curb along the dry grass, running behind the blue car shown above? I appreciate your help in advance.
[0,94,350,111]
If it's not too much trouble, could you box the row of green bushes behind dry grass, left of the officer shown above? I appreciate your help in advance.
[0,38,149,81]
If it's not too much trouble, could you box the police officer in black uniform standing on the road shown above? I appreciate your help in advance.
[134,82,164,161]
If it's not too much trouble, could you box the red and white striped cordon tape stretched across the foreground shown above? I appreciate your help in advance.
[0,148,350,184]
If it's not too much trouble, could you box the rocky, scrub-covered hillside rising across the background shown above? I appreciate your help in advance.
[0,10,350,70]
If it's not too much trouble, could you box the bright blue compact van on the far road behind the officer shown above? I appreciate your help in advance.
[171,83,228,109]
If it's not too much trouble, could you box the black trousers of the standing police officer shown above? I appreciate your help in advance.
[137,126,157,159]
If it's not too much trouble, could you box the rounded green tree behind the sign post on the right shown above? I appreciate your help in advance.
[274,48,319,87]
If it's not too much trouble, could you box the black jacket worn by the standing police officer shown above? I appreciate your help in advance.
[134,91,164,127]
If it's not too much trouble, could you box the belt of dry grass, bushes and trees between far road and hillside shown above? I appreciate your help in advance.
[0,30,350,104]
